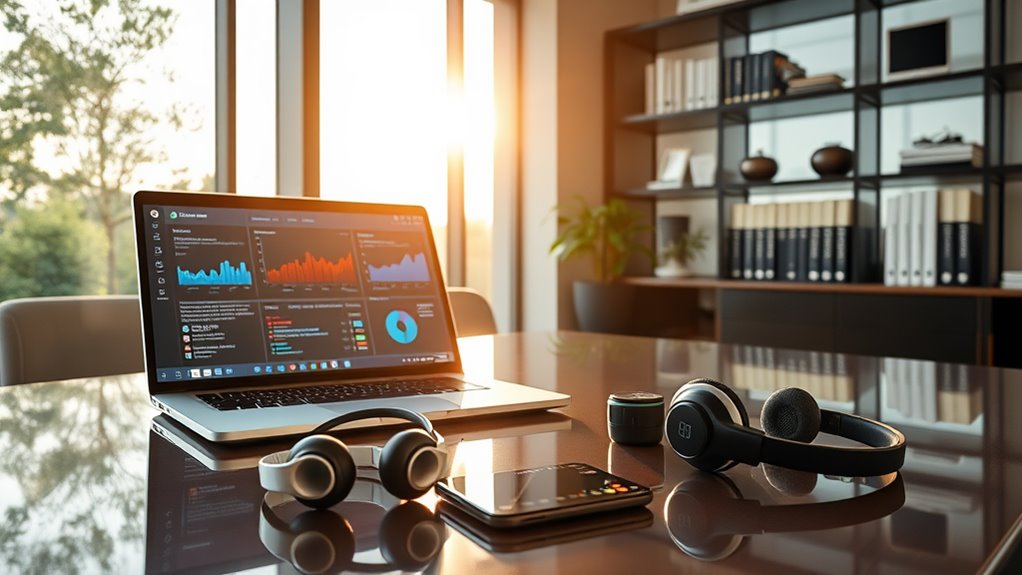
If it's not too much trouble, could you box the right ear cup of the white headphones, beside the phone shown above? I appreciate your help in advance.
[380,429,444,499]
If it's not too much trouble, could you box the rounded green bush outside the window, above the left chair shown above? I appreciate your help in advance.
[0,200,105,299]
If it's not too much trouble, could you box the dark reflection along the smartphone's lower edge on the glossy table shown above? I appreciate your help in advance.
[436,501,653,553]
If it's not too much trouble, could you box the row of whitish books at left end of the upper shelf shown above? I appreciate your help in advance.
[645,53,719,114]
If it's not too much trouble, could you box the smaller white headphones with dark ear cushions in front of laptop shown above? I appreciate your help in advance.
[259,408,448,509]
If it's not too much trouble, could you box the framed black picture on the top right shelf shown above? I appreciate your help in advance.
[887,18,951,82]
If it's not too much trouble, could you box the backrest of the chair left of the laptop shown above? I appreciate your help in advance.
[0,295,145,385]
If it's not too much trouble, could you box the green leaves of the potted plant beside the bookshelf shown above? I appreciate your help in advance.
[550,196,653,283]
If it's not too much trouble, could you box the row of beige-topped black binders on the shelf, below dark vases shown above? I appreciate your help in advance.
[727,199,852,282]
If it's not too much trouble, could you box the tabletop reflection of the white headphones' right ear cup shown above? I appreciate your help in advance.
[379,501,446,571]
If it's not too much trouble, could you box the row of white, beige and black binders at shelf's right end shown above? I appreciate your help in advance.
[884,188,982,286]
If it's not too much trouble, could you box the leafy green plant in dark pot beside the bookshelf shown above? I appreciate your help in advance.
[550,197,653,333]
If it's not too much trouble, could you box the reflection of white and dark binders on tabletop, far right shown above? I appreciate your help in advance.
[883,357,983,425]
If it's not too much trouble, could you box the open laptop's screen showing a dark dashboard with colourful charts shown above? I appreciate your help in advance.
[135,192,458,388]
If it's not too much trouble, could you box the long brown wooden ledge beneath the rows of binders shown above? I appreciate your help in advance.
[621,277,1022,297]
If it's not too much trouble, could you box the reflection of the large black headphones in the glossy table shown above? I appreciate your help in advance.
[663,473,904,561]
